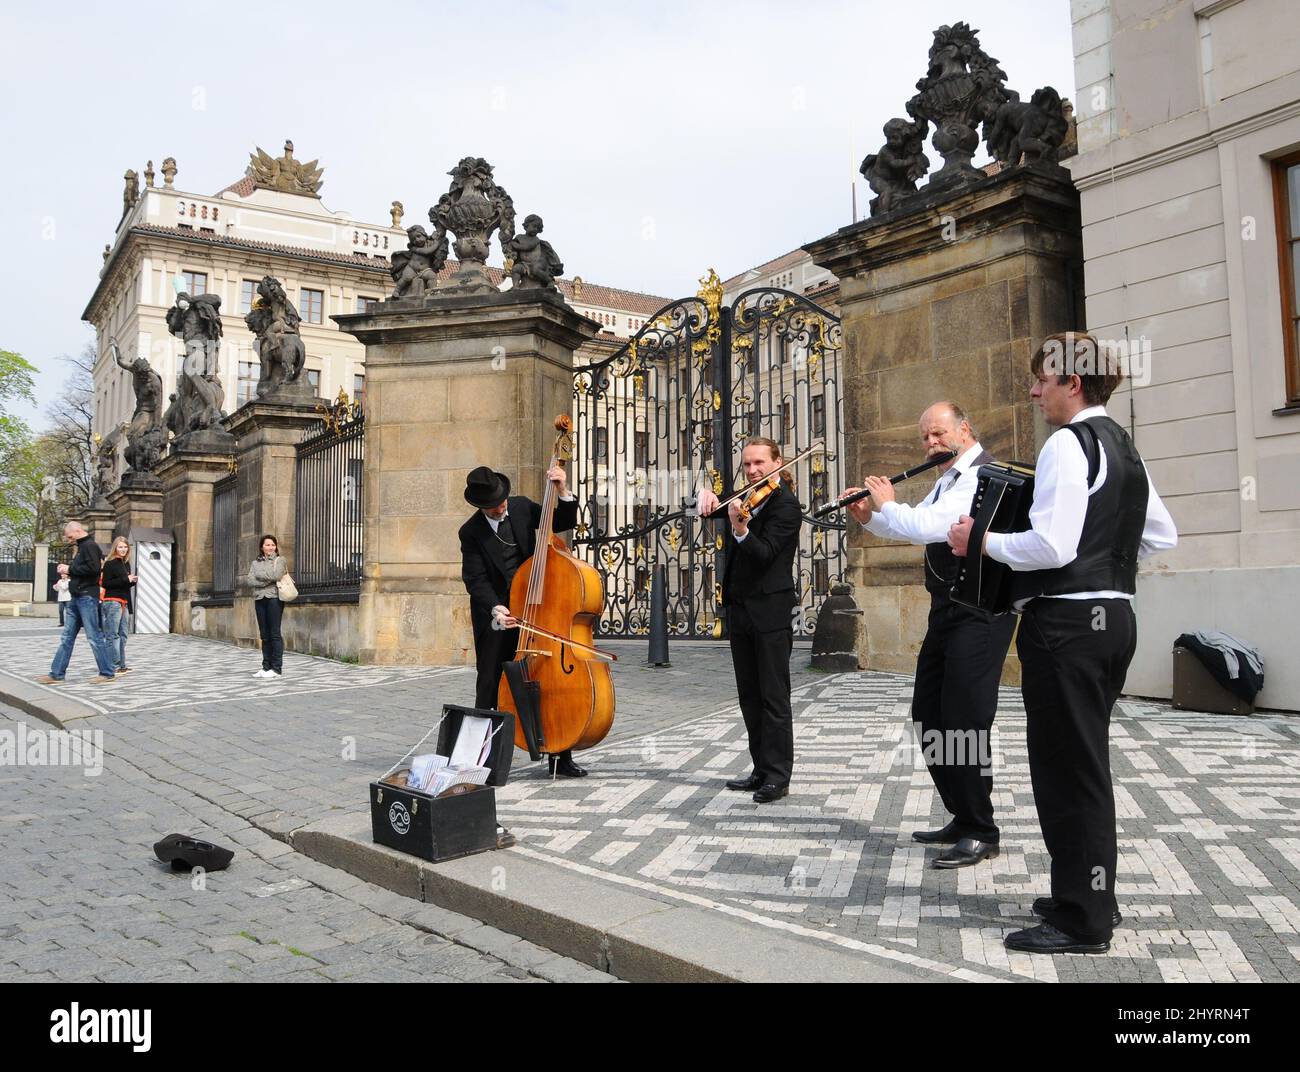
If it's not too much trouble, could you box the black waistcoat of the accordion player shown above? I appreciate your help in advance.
[1013,417,1151,599]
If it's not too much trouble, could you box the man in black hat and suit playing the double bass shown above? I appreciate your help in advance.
[460,465,586,778]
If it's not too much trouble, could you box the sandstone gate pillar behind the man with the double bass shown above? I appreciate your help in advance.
[334,290,598,664]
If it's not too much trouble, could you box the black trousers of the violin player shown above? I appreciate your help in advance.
[727,603,794,786]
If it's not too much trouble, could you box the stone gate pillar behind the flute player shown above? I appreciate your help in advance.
[803,168,1083,681]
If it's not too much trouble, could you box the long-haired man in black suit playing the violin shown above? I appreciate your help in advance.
[696,438,803,804]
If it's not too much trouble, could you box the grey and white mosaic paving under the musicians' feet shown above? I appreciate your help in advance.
[498,673,1300,982]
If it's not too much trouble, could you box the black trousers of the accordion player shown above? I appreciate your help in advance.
[1017,598,1138,942]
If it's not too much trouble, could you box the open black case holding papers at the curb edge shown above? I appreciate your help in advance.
[371,703,515,863]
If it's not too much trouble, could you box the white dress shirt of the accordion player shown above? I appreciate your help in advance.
[984,405,1178,606]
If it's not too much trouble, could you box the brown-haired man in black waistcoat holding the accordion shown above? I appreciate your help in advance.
[949,333,1178,952]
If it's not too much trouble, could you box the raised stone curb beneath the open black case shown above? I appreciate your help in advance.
[290,812,954,982]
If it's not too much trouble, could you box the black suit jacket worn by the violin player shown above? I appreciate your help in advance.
[711,483,803,633]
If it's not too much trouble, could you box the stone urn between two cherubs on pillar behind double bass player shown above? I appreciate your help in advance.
[429,156,515,294]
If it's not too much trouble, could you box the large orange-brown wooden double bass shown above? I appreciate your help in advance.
[497,415,616,760]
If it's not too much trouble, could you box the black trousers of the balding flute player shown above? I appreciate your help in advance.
[911,594,1015,842]
